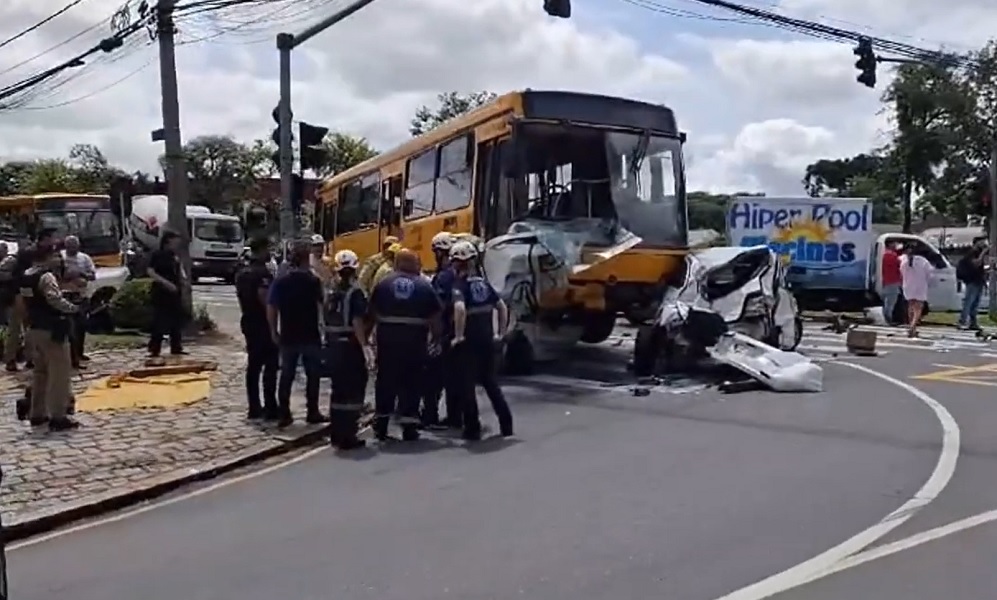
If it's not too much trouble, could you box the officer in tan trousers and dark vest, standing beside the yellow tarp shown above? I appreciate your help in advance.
[21,230,80,431]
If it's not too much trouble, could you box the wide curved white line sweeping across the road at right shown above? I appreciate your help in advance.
[718,362,962,600]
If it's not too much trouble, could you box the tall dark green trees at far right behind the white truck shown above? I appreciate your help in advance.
[803,41,997,230]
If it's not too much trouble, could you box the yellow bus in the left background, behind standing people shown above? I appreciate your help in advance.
[0,193,122,267]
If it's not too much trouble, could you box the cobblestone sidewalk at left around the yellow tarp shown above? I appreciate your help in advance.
[0,346,328,526]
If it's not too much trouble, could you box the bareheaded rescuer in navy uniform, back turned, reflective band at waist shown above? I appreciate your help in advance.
[370,249,443,441]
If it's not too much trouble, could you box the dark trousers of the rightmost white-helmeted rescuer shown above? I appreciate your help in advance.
[453,341,512,435]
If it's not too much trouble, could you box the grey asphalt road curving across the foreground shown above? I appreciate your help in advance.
[9,328,997,600]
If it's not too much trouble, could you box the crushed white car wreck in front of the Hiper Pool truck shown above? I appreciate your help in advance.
[633,246,803,376]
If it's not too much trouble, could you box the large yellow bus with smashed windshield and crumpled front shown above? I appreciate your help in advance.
[316,90,688,342]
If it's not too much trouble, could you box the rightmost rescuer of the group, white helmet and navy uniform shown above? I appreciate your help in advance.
[450,241,513,440]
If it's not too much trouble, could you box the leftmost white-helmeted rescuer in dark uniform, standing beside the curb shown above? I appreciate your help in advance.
[325,250,374,450]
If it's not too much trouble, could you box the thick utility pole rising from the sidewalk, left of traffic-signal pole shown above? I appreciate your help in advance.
[156,0,193,314]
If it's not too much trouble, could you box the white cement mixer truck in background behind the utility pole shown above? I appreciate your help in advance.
[128,195,245,283]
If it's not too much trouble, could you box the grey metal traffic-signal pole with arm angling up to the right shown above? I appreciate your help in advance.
[277,0,374,246]
